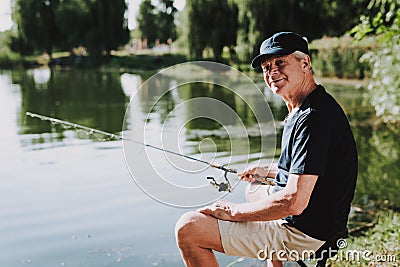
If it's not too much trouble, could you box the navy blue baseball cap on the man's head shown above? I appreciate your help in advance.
[251,32,310,68]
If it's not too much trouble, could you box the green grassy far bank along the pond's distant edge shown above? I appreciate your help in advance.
[0,41,371,80]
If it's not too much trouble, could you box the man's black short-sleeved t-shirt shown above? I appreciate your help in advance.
[275,85,358,240]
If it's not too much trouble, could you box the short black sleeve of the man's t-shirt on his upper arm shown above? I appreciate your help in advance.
[289,111,330,176]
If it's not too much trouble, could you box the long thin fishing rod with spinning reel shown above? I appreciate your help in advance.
[26,112,273,192]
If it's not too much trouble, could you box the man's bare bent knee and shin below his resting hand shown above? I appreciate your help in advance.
[175,212,224,267]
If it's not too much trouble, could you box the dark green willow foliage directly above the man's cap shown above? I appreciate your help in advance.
[236,0,369,62]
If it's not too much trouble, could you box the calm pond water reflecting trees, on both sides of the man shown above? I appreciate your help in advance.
[0,65,400,267]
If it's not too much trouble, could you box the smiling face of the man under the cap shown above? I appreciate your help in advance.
[261,55,305,97]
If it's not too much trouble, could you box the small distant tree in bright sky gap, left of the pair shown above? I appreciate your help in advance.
[137,0,158,46]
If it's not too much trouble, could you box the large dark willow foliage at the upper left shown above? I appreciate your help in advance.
[12,0,129,55]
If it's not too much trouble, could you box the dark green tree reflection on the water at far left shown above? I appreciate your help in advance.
[16,69,127,149]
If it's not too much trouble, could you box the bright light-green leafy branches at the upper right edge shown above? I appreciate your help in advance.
[350,0,400,122]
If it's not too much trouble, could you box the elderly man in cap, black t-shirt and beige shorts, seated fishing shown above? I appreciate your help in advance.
[176,32,358,267]
